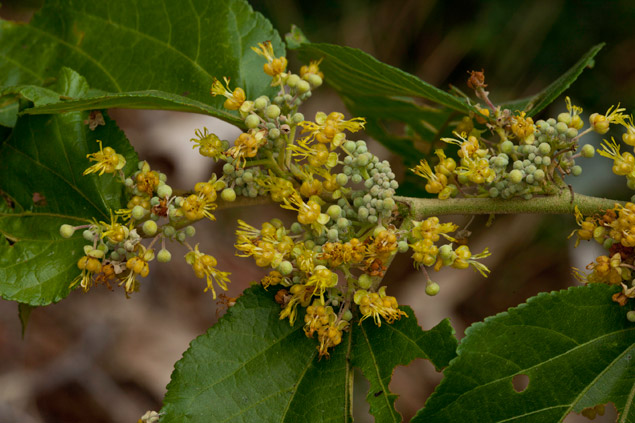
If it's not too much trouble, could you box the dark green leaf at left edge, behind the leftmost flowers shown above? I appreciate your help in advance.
[0,69,137,306]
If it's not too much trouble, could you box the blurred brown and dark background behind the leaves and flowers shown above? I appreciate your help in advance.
[0,0,635,423]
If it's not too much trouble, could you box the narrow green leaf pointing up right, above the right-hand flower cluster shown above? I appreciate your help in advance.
[504,43,604,116]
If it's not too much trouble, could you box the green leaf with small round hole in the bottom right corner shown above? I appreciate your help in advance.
[412,284,635,423]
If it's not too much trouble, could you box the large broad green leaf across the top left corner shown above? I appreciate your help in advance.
[0,0,284,122]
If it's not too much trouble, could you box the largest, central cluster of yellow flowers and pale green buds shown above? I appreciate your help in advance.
[199,43,489,357]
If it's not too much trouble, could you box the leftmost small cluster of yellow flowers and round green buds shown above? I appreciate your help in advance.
[60,151,228,298]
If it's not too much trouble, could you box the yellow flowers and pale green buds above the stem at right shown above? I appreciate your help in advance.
[412,78,635,199]
